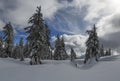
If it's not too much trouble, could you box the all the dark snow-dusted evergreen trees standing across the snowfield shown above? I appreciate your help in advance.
[0,7,111,65]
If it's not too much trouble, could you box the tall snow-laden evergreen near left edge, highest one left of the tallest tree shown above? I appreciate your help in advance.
[3,23,14,57]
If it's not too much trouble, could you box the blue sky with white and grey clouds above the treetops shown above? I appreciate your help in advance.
[0,0,120,54]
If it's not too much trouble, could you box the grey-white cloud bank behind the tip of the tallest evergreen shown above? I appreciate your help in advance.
[0,0,62,28]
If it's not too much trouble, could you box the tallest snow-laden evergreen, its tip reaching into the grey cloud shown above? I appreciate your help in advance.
[25,7,50,64]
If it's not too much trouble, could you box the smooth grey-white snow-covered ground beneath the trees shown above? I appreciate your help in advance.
[0,56,120,81]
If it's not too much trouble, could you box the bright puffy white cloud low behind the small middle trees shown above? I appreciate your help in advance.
[52,34,87,56]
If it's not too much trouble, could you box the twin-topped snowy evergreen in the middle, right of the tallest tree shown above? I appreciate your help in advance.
[54,35,68,60]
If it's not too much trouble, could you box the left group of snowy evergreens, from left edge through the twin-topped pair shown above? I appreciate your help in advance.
[0,7,68,65]
